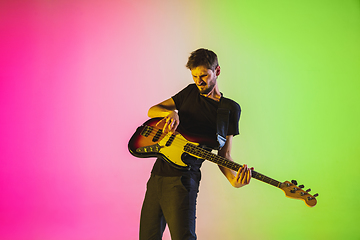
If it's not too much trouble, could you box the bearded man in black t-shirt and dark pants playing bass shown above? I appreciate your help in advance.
[140,48,251,240]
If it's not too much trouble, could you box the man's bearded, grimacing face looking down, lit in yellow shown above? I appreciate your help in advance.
[191,66,220,94]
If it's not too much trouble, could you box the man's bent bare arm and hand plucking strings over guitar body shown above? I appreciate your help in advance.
[148,98,180,132]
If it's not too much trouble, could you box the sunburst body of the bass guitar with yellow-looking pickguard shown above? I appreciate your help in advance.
[128,118,218,170]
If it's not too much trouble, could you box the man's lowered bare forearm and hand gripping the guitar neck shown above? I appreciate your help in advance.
[218,135,251,188]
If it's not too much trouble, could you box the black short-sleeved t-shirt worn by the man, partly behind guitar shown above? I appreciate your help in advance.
[152,84,241,180]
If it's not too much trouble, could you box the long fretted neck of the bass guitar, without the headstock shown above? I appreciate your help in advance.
[184,143,281,188]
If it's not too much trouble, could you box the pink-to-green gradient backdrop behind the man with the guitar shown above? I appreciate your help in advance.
[0,0,360,240]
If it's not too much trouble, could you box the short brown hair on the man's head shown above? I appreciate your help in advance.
[186,48,219,71]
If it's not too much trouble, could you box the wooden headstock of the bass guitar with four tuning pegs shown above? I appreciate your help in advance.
[280,180,319,207]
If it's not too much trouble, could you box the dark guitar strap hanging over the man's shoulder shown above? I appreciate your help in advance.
[216,97,230,148]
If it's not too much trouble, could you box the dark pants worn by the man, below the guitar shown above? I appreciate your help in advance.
[140,174,199,240]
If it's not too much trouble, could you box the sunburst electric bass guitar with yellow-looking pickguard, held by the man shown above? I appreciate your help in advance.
[128,118,318,207]
